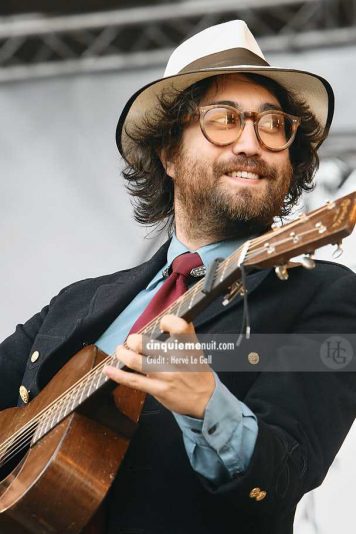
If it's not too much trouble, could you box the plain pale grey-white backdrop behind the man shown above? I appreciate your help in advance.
[0,43,356,534]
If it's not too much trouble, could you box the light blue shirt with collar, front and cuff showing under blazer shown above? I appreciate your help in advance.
[96,235,258,485]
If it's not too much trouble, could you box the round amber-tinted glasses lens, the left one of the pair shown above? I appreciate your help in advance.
[202,107,241,145]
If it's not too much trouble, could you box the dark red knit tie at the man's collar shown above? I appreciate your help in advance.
[129,252,202,334]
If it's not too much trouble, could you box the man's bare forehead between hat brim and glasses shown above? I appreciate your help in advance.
[201,74,279,106]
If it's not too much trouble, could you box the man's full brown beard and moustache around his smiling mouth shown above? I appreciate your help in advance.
[174,153,293,242]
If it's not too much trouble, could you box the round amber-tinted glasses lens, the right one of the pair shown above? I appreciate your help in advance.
[257,112,294,149]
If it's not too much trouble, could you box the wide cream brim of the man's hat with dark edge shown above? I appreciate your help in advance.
[116,65,334,157]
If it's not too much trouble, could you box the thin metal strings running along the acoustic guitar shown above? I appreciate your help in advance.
[0,222,336,463]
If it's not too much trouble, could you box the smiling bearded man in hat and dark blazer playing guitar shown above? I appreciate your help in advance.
[0,21,356,534]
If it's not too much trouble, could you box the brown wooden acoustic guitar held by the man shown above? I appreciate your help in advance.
[0,192,356,534]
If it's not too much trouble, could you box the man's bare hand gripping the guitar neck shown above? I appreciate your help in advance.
[103,315,215,419]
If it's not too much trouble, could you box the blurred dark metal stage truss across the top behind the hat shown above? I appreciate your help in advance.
[0,0,356,82]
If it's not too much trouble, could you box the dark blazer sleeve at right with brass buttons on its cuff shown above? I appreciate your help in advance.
[201,271,356,515]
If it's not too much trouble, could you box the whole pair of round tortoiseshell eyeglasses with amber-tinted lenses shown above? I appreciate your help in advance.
[190,104,301,152]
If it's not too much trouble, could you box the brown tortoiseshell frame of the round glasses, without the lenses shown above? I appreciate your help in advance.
[193,104,301,152]
